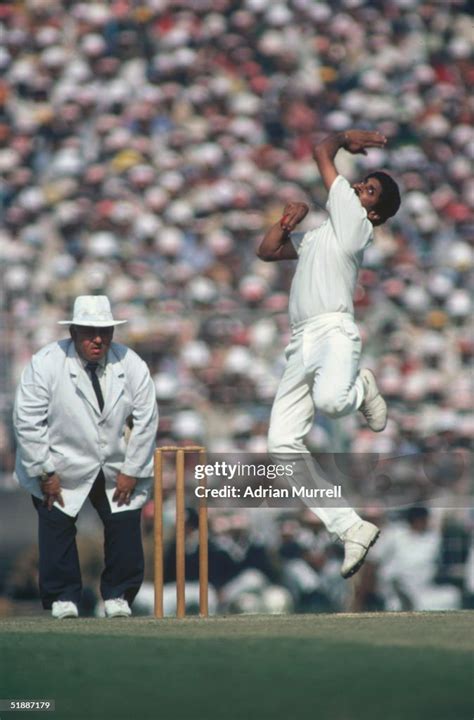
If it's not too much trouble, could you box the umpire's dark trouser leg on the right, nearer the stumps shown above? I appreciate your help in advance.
[89,472,144,605]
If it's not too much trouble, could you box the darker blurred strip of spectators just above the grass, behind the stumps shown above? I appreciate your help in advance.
[4,504,474,616]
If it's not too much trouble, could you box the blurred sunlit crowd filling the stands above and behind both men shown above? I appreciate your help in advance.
[0,0,474,612]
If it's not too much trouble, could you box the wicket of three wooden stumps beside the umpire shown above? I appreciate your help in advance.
[154,445,209,618]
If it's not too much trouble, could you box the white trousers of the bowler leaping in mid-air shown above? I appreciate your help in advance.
[268,313,364,535]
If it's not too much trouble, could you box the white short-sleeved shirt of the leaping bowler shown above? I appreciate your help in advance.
[289,175,373,325]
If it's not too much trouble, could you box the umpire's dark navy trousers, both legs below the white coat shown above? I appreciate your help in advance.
[33,470,144,609]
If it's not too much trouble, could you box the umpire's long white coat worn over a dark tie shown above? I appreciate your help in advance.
[13,340,158,516]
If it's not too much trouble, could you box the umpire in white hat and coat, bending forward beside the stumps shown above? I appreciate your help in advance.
[13,295,158,619]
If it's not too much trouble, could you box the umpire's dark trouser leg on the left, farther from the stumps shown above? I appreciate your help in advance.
[32,496,82,610]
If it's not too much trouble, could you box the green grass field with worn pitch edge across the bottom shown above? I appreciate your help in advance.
[0,611,474,720]
